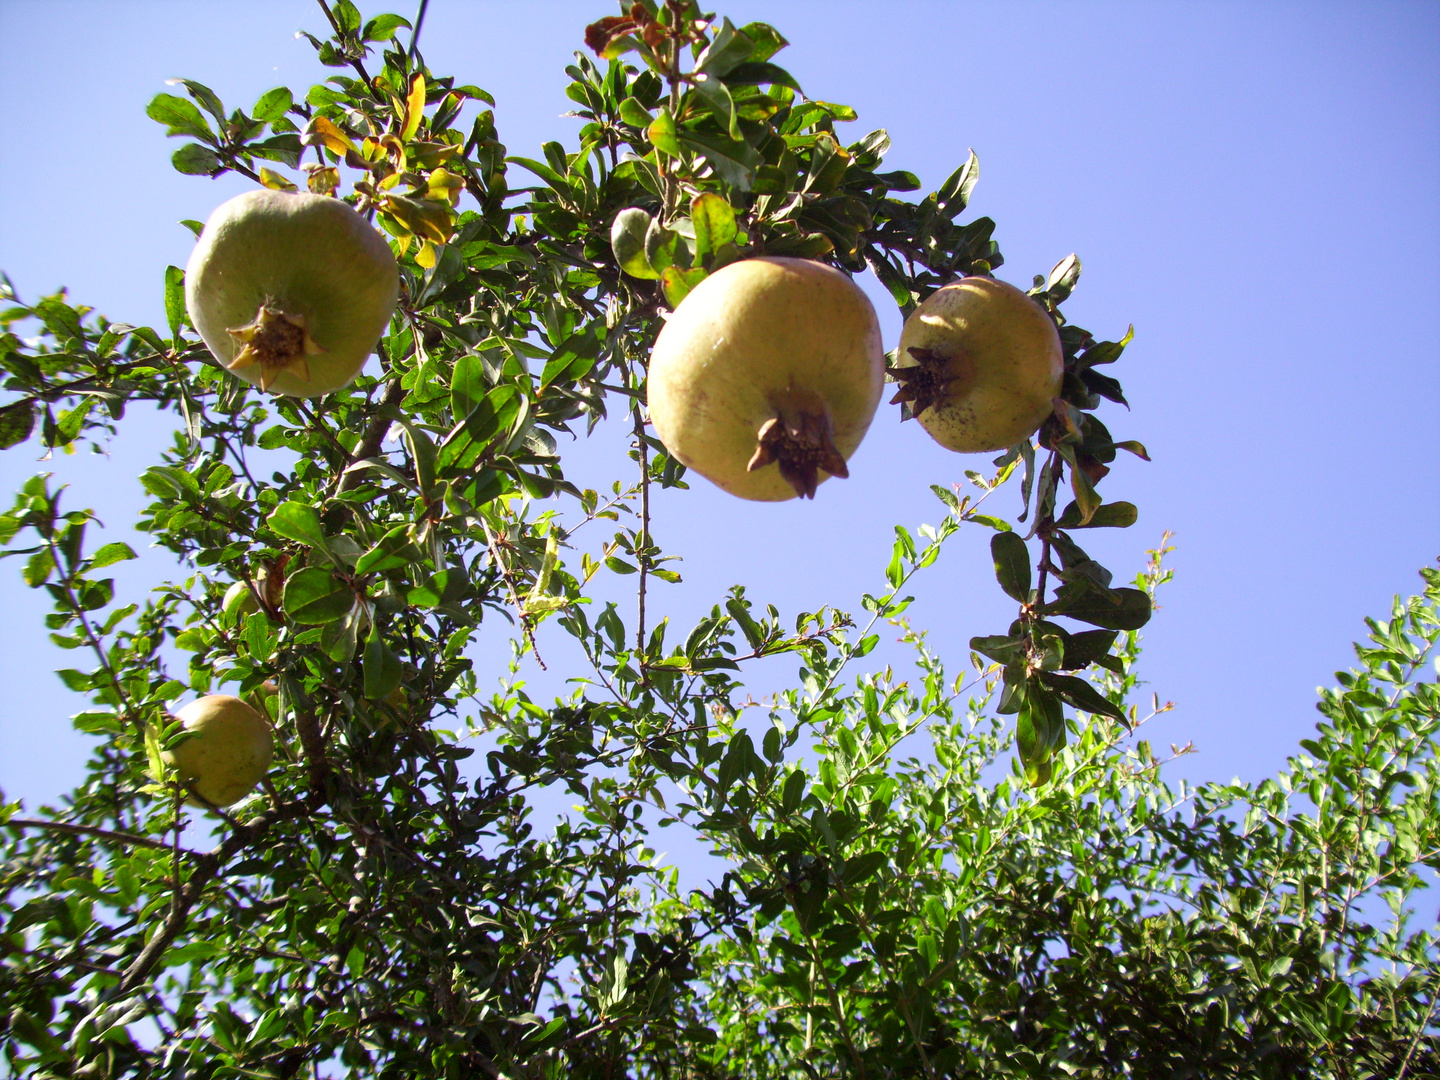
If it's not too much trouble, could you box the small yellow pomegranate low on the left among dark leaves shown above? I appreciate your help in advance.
[163,694,275,806]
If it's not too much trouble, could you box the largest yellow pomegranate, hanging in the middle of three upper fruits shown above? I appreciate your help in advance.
[649,256,884,501]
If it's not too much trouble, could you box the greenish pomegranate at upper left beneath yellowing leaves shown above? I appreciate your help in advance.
[184,190,399,397]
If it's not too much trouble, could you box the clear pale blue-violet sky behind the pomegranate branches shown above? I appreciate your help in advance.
[0,0,1440,835]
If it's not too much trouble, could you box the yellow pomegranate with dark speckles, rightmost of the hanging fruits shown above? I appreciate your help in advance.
[890,276,1064,454]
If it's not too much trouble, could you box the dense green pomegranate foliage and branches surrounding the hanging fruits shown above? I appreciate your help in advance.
[0,0,1440,1077]
